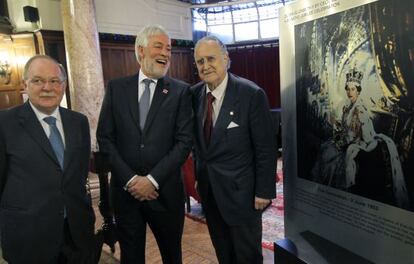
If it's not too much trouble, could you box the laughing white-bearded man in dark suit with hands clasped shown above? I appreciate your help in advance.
[97,26,193,263]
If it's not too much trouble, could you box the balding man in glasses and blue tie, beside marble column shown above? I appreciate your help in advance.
[0,55,95,264]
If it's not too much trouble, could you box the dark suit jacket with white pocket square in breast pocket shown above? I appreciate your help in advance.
[191,73,276,225]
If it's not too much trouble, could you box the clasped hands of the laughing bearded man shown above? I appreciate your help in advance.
[127,175,159,201]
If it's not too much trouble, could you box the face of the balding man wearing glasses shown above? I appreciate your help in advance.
[24,58,66,114]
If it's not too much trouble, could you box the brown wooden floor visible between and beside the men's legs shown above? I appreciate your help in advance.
[92,176,274,264]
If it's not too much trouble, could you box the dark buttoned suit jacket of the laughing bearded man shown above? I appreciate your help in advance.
[97,74,193,213]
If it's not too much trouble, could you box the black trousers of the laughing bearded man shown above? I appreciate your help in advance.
[115,202,184,264]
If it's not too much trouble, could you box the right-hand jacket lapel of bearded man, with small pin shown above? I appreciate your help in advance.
[143,77,170,133]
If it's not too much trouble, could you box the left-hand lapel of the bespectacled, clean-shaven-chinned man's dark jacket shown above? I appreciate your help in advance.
[19,102,59,165]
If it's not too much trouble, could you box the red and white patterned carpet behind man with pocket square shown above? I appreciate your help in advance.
[187,159,285,250]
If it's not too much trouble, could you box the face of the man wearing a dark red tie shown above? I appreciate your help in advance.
[194,40,229,90]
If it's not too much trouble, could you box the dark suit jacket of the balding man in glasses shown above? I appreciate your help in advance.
[0,103,95,263]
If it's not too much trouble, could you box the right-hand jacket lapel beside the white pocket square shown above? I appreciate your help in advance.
[209,73,239,149]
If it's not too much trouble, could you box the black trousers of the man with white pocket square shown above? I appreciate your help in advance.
[203,188,263,264]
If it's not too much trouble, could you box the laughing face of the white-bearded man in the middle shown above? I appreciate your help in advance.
[138,34,171,79]
